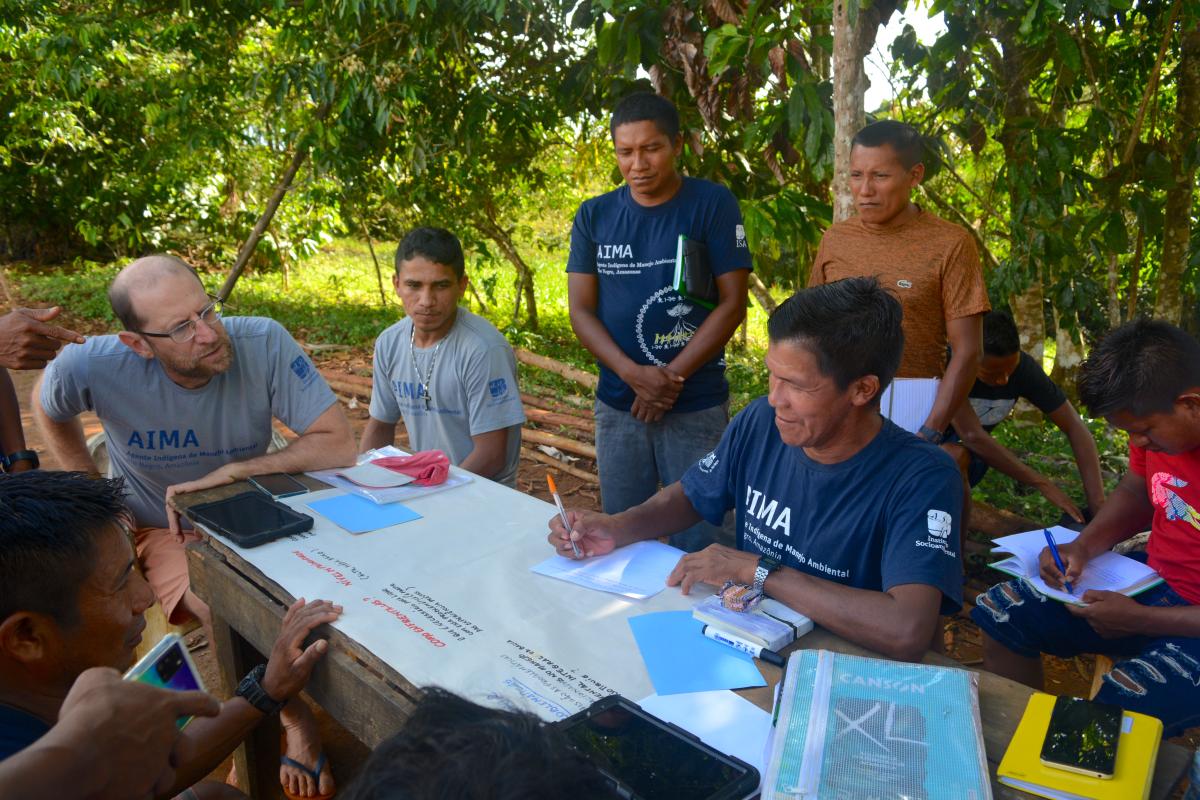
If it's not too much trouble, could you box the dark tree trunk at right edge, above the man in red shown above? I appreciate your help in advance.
[1154,24,1200,325]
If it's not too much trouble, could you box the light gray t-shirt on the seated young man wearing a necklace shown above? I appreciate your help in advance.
[371,308,524,487]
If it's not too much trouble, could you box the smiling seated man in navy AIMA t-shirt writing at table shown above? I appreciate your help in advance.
[548,277,962,661]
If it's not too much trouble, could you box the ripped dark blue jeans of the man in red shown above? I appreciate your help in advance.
[971,581,1200,736]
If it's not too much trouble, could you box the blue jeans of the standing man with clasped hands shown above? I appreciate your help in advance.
[595,401,734,553]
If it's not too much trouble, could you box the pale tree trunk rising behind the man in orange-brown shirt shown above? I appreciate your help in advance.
[832,0,896,222]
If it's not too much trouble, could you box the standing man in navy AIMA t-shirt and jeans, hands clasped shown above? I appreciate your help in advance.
[566,92,750,552]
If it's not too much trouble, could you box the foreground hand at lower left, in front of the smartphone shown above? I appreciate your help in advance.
[55,667,221,800]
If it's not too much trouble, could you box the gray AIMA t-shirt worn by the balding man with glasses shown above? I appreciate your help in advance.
[41,317,337,528]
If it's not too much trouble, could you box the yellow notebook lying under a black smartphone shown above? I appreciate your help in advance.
[996,692,1163,800]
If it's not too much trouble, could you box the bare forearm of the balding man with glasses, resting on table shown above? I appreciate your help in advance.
[166,402,356,535]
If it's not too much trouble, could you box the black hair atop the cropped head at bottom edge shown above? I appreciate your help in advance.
[343,688,617,800]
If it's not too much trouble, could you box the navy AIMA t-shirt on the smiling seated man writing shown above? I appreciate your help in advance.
[682,397,962,614]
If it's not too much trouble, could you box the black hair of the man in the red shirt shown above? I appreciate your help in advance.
[1076,318,1200,416]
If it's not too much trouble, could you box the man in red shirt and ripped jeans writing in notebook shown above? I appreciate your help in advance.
[971,319,1200,736]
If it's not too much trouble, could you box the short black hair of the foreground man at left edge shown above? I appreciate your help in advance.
[0,469,126,627]
